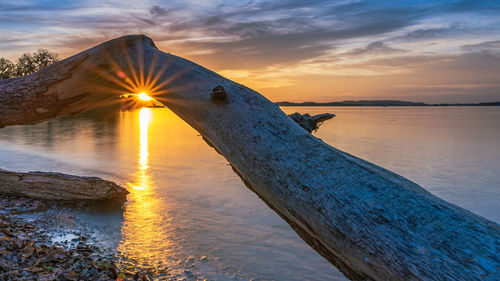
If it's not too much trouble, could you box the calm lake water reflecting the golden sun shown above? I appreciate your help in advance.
[0,107,500,280]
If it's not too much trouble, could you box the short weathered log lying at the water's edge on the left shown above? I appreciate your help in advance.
[0,169,128,202]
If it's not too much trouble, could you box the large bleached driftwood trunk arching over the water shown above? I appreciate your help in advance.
[0,36,500,280]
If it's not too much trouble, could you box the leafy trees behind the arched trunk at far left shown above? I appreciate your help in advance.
[0,49,58,79]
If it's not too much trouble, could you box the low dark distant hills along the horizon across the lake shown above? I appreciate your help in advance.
[276,100,500,106]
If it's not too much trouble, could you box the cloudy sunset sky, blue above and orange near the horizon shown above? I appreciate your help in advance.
[0,0,500,103]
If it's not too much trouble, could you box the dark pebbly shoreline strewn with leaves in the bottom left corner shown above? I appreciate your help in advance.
[0,195,151,281]
